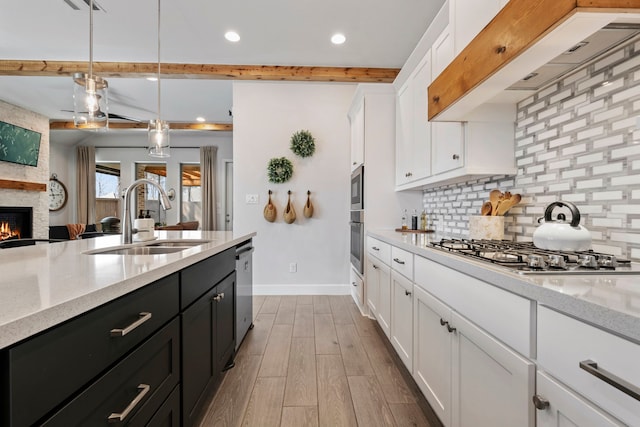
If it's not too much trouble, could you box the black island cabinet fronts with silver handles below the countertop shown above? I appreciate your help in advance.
[0,248,236,427]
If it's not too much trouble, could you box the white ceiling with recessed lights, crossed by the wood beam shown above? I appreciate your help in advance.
[0,0,444,145]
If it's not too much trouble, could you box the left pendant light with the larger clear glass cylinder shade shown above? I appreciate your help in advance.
[73,0,109,130]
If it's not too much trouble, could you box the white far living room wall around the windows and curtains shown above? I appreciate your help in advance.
[49,132,233,229]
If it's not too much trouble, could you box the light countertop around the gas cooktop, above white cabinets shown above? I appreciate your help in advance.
[367,230,640,343]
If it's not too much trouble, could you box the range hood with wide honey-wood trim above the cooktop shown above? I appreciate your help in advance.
[428,0,640,121]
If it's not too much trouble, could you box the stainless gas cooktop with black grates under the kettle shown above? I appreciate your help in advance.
[431,239,640,274]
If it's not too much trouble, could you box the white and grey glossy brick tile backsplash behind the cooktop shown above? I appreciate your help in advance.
[424,42,640,262]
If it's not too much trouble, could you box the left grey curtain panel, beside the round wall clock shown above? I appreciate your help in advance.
[76,146,96,224]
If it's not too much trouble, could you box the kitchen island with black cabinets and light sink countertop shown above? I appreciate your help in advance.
[0,231,255,426]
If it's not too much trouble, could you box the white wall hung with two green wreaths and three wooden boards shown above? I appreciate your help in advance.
[233,82,356,294]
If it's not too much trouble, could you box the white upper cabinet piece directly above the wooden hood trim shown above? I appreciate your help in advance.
[449,0,508,59]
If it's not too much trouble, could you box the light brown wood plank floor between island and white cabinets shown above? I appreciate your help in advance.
[200,295,439,427]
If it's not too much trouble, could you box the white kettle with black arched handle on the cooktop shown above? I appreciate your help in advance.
[533,202,591,251]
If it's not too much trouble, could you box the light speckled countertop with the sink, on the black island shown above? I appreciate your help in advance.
[0,231,255,349]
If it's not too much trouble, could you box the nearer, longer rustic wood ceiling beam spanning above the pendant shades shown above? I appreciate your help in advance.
[0,59,400,83]
